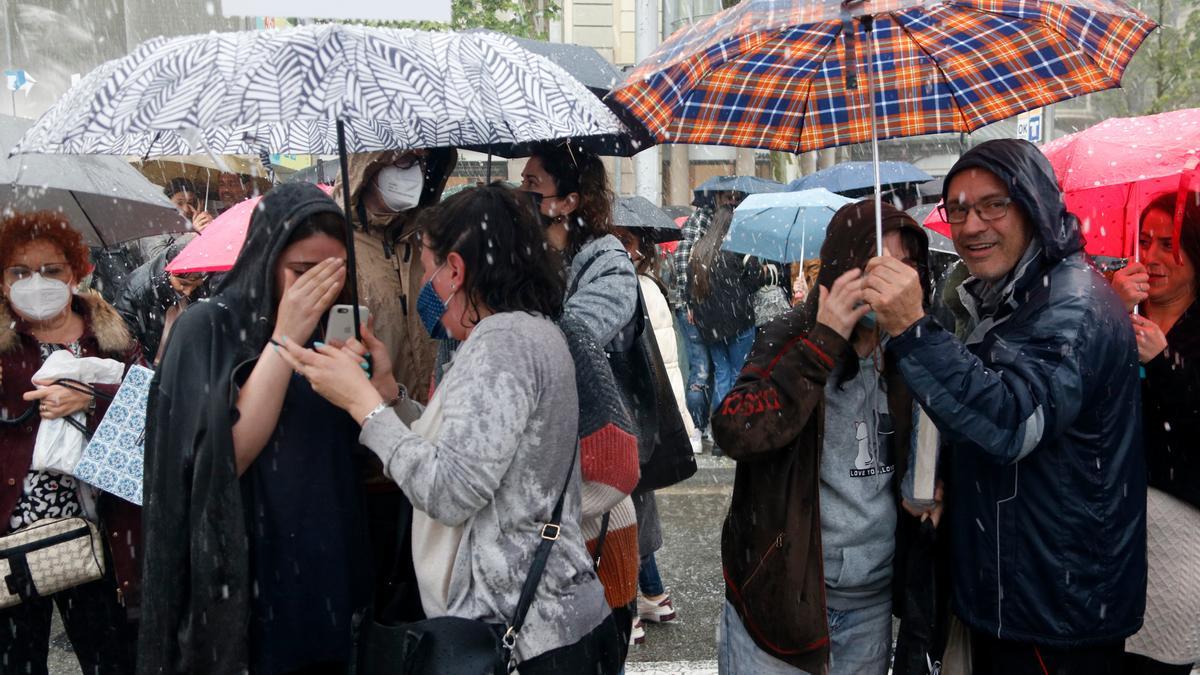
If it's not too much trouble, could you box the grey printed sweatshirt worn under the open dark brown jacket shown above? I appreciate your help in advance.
[821,357,896,610]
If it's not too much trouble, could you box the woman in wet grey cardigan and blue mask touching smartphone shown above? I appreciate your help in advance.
[280,186,620,675]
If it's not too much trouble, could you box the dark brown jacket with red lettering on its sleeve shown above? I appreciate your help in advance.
[713,301,912,673]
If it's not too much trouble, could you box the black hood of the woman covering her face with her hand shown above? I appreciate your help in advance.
[214,183,344,352]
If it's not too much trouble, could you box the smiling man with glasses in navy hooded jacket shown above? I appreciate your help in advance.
[864,139,1146,675]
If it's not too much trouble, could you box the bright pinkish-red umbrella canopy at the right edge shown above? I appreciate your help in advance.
[1042,108,1200,257]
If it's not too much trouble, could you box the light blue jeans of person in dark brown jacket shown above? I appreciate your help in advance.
[716,598,892,675]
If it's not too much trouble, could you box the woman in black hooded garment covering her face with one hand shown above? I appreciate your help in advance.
[139,184,395,674]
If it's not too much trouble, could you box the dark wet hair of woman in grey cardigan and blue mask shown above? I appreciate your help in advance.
[418,184,566,321]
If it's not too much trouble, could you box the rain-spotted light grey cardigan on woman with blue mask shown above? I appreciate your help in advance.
[360,312,608,661]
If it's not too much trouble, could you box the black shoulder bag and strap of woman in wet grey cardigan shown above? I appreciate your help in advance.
[356,453,578,675]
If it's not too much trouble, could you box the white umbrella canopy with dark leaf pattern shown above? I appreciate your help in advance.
[17,24,622,156]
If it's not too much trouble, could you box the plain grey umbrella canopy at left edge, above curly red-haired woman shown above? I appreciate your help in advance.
[0,115,184,247]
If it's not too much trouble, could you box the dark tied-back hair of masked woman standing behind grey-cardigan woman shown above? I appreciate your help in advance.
[530,143,614,257]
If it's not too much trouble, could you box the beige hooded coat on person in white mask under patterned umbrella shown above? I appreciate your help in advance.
[334,150,457,404]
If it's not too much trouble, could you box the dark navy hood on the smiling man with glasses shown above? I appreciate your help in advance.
[942,138,1084,262]
